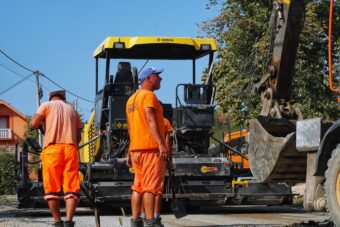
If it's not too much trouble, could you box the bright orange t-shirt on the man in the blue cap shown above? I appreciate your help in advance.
[126,89,165,151]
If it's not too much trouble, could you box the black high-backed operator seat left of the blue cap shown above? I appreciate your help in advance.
[113,62,134,96]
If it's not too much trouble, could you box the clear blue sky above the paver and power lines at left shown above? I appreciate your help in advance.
[0,0,219,120]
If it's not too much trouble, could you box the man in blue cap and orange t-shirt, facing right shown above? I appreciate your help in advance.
[126,68,169,227]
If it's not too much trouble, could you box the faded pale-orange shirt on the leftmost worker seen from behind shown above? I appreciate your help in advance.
[37,100,82,149]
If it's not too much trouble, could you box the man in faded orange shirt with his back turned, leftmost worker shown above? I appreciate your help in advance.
[30,90,82,227]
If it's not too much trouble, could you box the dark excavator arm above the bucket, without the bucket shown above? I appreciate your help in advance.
[255,0,304,118]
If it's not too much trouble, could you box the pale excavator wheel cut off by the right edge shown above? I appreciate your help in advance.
[325,144,340,226]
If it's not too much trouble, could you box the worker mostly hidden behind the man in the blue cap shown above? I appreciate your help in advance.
[140,118,173,227]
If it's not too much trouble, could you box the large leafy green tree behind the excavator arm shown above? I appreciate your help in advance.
[201,0,340,126]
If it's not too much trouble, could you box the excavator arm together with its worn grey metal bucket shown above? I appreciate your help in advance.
[249,0,339,182]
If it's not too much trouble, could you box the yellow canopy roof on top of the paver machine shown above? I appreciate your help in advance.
[93,36,217,60]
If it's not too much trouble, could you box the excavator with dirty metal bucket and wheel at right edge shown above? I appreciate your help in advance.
[249,0,340,223]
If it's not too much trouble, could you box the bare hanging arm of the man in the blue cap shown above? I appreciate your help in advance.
[144,108,169,159]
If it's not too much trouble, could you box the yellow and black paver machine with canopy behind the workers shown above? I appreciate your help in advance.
[80,37,291,224]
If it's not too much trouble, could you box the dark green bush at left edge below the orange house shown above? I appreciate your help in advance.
[0,154,15,195]
